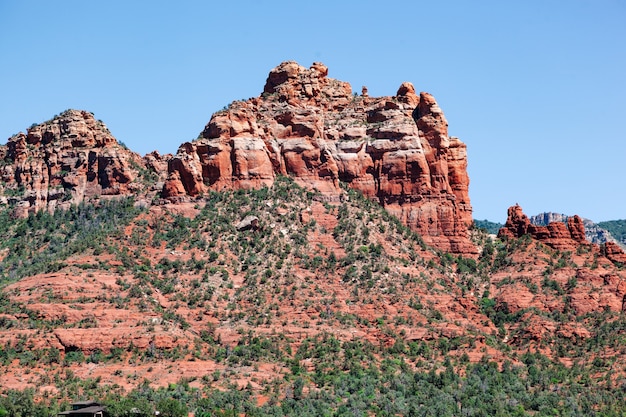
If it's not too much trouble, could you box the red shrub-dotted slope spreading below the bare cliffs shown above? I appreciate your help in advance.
[0,178,626,415]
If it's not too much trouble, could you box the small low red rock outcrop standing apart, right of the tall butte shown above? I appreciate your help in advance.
[498,205,591,250]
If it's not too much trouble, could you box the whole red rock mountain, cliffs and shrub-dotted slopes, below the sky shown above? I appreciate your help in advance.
[0,62,626,417]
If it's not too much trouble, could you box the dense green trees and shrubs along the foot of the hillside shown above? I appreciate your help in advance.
[0,348,624,417]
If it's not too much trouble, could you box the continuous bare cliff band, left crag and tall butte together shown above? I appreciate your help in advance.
[0,62,477,254]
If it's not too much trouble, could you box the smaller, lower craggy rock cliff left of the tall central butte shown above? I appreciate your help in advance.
[0,110,165,215]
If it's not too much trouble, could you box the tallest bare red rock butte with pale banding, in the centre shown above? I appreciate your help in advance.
[163,62,476,254]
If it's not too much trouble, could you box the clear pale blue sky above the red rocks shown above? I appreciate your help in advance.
[0,0,626,222]
